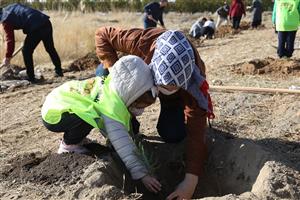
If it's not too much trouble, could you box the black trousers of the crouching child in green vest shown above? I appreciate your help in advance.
[43,113,93,144]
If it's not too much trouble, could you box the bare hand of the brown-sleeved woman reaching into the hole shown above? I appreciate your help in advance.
[167,174,198,200]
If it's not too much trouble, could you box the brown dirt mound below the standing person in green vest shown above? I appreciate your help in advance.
[231,58,300,76]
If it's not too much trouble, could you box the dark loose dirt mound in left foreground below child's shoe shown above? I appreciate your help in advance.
[1,153,95,184]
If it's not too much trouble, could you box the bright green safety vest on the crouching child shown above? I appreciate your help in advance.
[42,76,131,131]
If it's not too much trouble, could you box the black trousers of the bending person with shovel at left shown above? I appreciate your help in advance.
[22,21,62,80]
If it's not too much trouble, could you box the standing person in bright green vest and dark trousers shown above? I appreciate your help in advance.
[272,0,300,58]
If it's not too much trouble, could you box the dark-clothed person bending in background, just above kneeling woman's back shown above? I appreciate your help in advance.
[144,0,168,29]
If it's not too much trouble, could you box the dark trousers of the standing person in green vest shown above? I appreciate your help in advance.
[277,31,297,58]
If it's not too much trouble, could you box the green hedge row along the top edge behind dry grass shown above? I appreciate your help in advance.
[0,0,272,13]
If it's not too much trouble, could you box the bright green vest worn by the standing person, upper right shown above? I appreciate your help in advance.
[272,0,300,31]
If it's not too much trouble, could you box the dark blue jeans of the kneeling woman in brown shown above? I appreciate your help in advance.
[96,64,186,143]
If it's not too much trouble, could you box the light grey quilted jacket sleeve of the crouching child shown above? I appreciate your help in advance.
[102,115,148,180]
